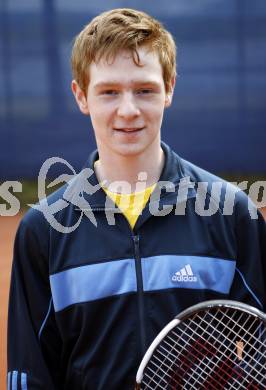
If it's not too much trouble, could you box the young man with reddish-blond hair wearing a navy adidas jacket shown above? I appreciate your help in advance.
[8,9,266,390]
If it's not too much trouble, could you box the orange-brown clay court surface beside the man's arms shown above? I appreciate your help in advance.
[0,207,266,389]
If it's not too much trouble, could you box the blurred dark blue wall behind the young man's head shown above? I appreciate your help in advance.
[0,0,266,180]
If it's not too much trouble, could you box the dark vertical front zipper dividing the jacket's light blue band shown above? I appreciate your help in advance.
[133,235,146,356]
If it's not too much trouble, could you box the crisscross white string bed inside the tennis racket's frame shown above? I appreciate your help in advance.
[142,309,266,390]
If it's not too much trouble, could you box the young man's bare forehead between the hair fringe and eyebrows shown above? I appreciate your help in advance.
[89,48,163,88]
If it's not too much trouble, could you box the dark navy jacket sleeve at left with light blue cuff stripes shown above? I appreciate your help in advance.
[7,218,61,390]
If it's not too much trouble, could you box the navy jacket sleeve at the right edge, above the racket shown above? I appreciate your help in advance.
[230,197,266,312]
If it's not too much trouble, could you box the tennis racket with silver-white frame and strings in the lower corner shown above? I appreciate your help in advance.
[135,300,266,390]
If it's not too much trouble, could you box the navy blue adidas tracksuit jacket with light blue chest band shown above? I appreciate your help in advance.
[8,144,266,390]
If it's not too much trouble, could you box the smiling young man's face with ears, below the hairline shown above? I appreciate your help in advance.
[72,48,172,156]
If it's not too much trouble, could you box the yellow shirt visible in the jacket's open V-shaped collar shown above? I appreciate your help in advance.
[103,184,156,229]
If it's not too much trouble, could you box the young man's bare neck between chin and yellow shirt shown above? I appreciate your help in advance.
[95,145,164,193]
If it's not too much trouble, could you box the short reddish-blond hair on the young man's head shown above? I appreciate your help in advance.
[71,8,176,93]
